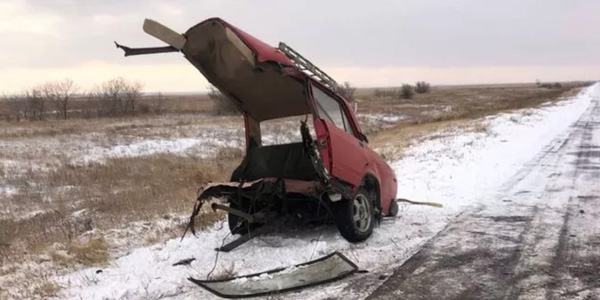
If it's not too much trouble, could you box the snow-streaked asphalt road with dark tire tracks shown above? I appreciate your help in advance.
[367,92,600,299]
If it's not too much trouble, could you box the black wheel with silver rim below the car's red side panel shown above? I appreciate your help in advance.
[333,188,375,243]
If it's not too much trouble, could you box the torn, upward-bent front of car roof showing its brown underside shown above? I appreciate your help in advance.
[181,18,309,121]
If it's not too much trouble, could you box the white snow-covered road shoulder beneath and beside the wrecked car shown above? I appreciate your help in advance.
[59,84,600,299]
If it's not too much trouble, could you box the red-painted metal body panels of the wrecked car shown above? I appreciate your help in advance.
[185,18,397,215]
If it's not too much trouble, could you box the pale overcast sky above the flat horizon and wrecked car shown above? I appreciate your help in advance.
[0,0,600,93]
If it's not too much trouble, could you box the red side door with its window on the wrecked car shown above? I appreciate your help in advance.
[311,84,367,186]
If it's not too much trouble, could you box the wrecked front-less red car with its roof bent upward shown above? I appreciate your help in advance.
[117,18,398,251]
